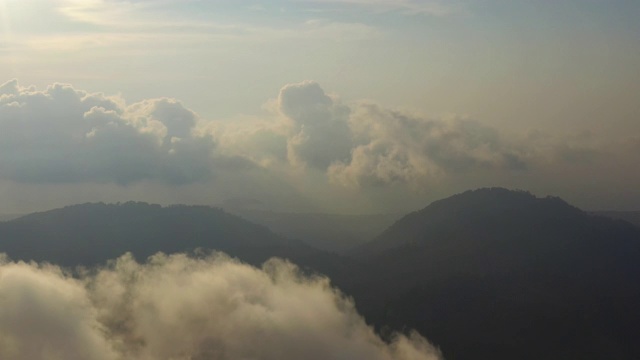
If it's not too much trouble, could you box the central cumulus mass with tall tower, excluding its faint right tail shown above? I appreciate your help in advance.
[217,81,528,189]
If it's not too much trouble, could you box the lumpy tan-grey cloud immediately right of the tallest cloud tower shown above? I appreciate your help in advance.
[328,103,526,188]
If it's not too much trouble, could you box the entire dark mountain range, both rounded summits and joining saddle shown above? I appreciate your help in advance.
[0,189,640,360]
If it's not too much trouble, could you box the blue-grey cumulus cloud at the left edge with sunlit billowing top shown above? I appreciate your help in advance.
[0,80,214,184]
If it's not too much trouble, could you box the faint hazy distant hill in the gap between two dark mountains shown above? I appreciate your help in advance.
[228,209,402,253]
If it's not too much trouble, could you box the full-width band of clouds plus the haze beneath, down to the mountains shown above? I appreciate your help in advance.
[0,80,640,212]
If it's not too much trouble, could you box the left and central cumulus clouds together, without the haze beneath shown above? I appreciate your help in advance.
[0,80,608,188]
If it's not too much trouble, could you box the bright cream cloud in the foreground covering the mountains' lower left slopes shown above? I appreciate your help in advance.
[0,254,439,360]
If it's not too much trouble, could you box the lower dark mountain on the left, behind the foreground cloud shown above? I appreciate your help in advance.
[0,202,352,277]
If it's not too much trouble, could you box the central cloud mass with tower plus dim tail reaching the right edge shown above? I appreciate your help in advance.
[212,81,633,200]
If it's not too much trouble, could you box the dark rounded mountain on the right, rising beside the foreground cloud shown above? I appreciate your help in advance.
[350,188,640,360]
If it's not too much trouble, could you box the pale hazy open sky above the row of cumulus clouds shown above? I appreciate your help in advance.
[2,0,640,124]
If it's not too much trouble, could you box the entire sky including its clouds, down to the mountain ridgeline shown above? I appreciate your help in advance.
[0,0,640,214]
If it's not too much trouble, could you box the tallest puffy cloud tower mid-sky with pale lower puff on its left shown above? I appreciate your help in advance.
[210,81,353,172]
